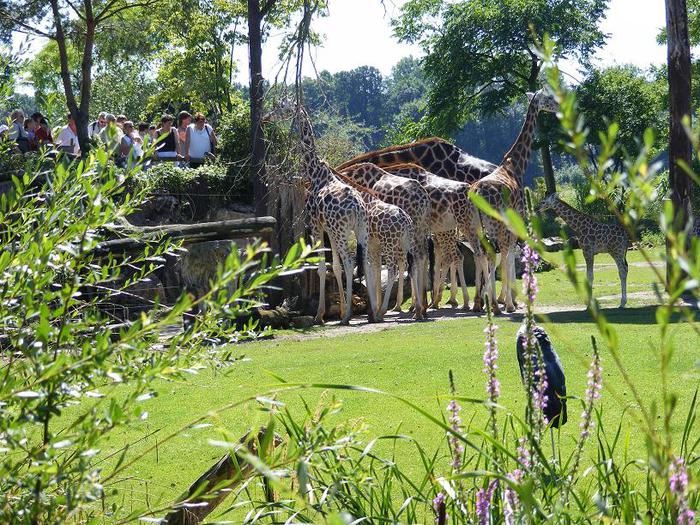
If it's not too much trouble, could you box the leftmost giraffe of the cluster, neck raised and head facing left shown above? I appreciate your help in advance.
[271,101,377,324]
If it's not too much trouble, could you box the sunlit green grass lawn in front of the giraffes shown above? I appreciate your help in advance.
[67,247,700,520]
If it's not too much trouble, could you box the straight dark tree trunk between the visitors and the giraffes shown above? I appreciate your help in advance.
[248,0,267,217]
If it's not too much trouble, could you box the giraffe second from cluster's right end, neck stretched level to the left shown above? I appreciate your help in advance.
[384,164,479,309]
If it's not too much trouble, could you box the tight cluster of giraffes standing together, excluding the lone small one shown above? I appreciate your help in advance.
[272,90,627,324]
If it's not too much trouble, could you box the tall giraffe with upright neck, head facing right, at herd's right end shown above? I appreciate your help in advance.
[471,90,559,313]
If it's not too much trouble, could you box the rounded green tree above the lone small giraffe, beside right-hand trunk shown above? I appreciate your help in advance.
[576,65,668,167]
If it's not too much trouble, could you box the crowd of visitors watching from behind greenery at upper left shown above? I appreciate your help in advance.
[0,109,217,167]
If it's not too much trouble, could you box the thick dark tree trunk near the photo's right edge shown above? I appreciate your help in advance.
[666,0,692,286]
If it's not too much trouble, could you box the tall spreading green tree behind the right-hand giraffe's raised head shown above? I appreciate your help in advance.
[395,0,607,191]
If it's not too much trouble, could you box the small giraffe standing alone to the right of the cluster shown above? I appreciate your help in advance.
[538,193,629,308]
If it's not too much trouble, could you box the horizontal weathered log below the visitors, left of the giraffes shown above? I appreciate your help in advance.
[94,217,277,254]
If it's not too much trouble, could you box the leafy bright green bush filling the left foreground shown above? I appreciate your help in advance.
[0,151,308,524]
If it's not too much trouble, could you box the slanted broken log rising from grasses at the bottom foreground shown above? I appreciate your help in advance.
[162,427,282,525]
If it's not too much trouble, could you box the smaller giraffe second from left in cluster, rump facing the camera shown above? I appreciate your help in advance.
[338,172,425,321]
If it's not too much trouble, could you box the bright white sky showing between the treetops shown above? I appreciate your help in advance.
[10,0,666,90]
